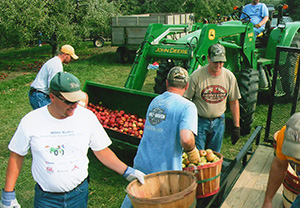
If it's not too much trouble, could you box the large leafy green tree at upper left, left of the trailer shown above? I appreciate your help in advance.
[0,0,117,55]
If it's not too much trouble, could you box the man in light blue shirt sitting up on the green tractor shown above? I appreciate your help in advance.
[241,0,269,37]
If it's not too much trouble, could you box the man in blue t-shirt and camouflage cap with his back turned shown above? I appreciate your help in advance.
[122,67,200,208]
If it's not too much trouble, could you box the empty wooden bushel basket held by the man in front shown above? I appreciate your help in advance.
[126,171,197,208]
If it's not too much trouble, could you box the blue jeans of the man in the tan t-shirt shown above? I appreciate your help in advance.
[195,114,225,152]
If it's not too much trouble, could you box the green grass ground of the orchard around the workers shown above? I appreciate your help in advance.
[0,42,274,208]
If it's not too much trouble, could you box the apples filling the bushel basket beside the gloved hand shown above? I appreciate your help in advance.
[182,149,220,168]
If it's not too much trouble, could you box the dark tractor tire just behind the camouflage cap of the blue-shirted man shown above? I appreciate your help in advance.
[154,61,174,94]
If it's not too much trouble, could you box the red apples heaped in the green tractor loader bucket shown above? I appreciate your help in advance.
[87,103,146,138]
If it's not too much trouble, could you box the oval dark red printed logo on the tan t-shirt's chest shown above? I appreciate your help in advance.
[201,85,227,104]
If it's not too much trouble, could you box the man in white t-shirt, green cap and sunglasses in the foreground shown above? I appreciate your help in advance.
[0,72,144,208]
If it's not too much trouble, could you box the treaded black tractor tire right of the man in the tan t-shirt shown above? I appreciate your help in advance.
[238,69,259,135]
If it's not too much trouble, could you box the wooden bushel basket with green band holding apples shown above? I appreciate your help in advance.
[183,152,223,198]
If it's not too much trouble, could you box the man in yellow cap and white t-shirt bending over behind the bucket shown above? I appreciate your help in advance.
[29,45,78,109]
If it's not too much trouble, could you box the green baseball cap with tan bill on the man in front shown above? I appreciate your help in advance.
[50,72,85,102]
